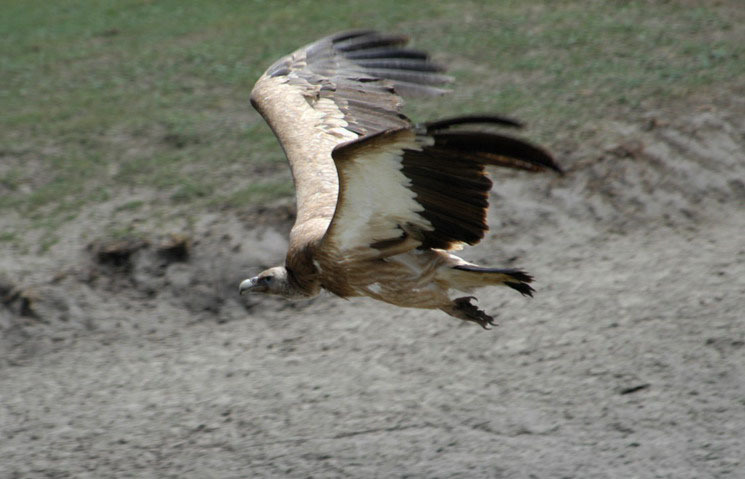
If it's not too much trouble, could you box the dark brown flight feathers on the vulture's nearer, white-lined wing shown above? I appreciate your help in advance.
[401,115,561,249]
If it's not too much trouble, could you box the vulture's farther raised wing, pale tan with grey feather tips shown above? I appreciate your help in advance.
[251,30,450,231]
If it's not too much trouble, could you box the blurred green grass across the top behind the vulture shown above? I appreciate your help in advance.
[0,0,745,236]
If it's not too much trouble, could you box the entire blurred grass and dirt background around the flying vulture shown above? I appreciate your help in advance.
[0,0,745,478]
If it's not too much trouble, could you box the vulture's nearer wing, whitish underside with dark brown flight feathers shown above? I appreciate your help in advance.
[323,115,560,262]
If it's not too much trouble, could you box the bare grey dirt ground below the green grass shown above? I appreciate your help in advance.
[0,100,745,479]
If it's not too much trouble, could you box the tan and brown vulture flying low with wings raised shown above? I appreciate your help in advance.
[239,30,561,329]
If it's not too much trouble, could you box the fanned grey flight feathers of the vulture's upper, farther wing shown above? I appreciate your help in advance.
[260,30,451,136]
